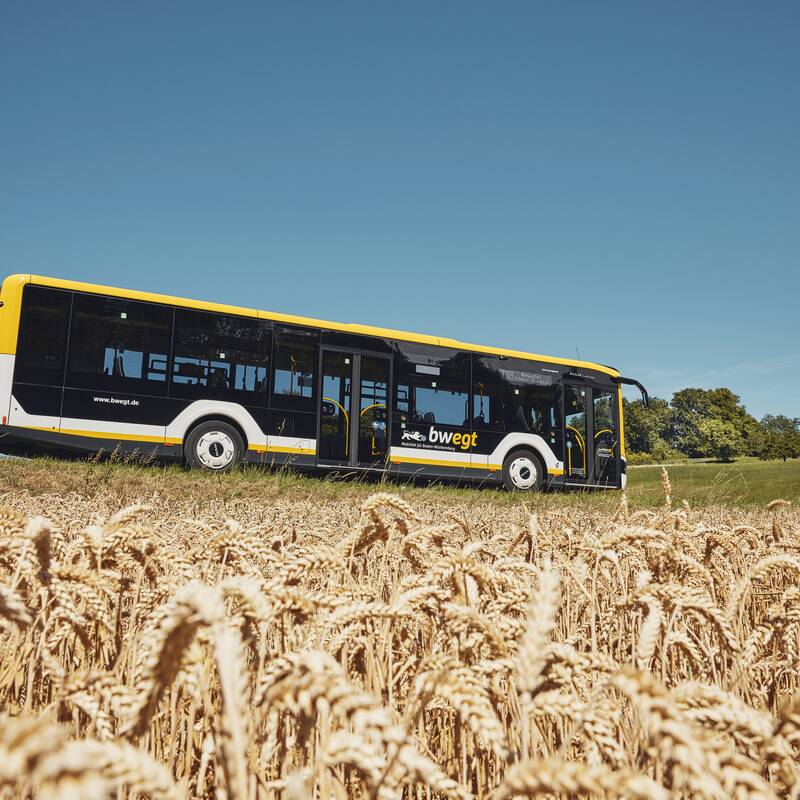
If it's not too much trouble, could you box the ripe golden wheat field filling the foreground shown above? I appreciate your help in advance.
[0,462,800,800]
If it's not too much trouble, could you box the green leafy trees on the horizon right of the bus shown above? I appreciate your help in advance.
[623,388,800,463]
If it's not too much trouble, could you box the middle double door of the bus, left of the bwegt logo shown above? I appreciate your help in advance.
[317,348,392,467]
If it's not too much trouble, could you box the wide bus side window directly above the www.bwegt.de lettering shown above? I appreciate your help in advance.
[67,293,172,396]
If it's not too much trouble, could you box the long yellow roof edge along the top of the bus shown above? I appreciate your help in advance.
[3,275,620,377]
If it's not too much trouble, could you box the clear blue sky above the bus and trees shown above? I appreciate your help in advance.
[0,1,800,416]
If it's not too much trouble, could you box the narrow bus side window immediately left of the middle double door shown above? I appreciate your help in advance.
[272,327,319,411]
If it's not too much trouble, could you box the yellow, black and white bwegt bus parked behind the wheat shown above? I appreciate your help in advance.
[0,275,646,491]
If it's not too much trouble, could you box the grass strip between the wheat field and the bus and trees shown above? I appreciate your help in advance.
[0,457,800,509]
